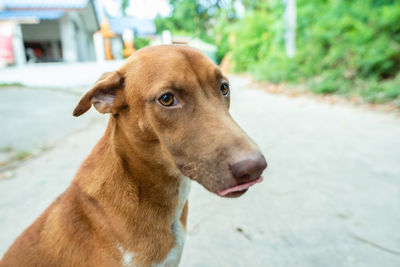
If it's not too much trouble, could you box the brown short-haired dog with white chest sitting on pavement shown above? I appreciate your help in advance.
[0,45,266,266]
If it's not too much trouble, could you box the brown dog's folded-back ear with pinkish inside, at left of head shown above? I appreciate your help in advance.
[72,71,124,117]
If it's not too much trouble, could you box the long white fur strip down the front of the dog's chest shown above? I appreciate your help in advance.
[152,176,191,267]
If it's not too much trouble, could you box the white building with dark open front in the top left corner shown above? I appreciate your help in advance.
[0,0,99,64]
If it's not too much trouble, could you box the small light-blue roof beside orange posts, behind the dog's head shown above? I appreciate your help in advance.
[109,17,156,35]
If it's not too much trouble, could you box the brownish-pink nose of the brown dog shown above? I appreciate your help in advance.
[229,152,267,182]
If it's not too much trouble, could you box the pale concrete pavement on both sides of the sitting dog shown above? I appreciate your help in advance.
[0,74,400,267]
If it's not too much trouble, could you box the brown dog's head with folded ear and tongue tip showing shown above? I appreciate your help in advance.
[73,45,267,197]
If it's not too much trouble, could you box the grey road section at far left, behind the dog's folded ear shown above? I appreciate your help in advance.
[0,87,85,151]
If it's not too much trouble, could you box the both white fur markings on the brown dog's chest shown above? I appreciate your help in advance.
[118,176,191,267]
